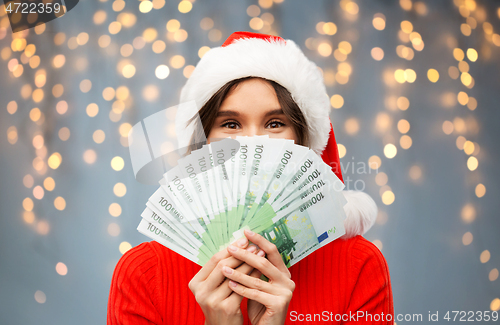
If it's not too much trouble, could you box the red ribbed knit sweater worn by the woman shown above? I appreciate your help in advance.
[107,236,394,325]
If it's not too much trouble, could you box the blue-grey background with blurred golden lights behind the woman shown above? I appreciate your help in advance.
[0,0,500,324]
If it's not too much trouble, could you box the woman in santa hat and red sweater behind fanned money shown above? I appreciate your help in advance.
[108,32,393,325]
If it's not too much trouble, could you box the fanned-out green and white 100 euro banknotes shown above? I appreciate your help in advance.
[137,136,346,267]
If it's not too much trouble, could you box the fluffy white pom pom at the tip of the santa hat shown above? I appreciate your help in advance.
[342,191,378,238]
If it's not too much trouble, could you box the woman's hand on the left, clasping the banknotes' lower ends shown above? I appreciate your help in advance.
[189,237,264,325]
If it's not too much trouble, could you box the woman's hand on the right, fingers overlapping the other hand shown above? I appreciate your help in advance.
[222,230,295,325]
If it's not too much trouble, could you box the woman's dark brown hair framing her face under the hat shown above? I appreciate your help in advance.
[191,76,309,146]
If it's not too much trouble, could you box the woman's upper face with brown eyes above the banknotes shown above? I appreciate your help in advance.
[208,78,297,143]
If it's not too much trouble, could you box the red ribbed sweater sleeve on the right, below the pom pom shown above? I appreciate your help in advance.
[343,237,394,324]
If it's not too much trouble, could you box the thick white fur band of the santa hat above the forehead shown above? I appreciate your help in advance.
[180,38,330,155]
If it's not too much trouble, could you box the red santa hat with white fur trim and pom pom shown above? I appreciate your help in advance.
[180,32,377,238]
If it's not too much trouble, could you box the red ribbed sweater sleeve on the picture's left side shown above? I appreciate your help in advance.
[107,243,163,325]
